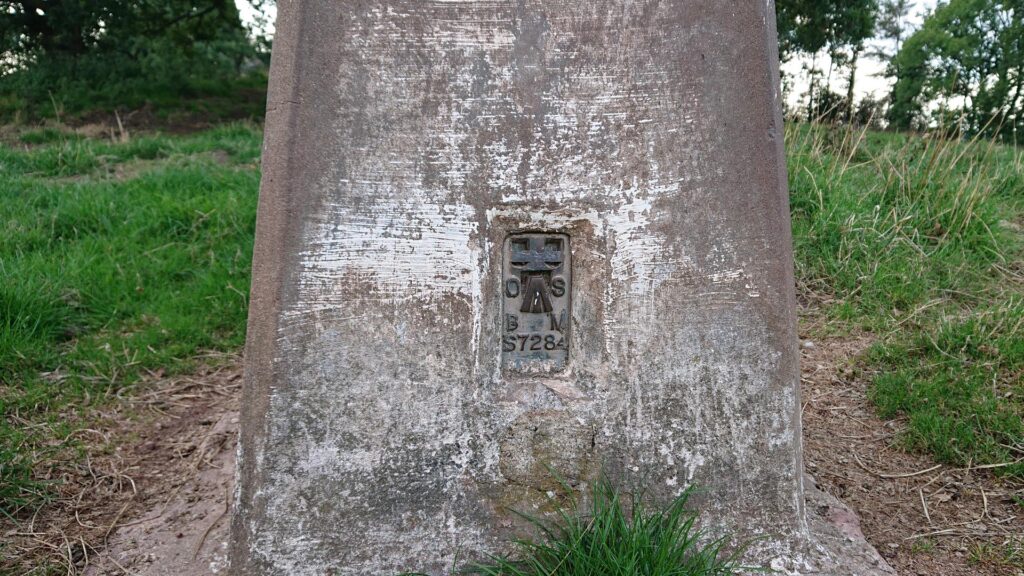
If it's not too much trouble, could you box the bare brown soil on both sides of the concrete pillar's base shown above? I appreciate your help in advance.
[0,330,1024,576]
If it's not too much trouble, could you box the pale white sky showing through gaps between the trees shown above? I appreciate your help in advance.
[234,0,938,106]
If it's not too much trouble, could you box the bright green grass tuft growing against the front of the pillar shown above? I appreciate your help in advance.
[403,482,757,576]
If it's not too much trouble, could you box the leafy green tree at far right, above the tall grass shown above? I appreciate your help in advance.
[889,0,1024,135]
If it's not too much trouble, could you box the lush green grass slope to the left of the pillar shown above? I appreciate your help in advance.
[0,124,261,516]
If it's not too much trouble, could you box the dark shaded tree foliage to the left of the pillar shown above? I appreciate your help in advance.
[0,0,270,115]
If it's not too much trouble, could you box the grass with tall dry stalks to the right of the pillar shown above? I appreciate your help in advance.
[788,125,1024,477]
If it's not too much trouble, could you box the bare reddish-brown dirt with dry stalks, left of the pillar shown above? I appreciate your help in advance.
[0,357,242,576]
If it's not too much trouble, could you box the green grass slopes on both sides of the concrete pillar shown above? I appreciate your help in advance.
[0,114,1024,522]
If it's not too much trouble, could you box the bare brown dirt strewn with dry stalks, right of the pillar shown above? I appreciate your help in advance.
[802,317,1024,576]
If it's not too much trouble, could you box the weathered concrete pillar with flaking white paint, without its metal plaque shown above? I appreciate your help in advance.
[232,0,880,574]
